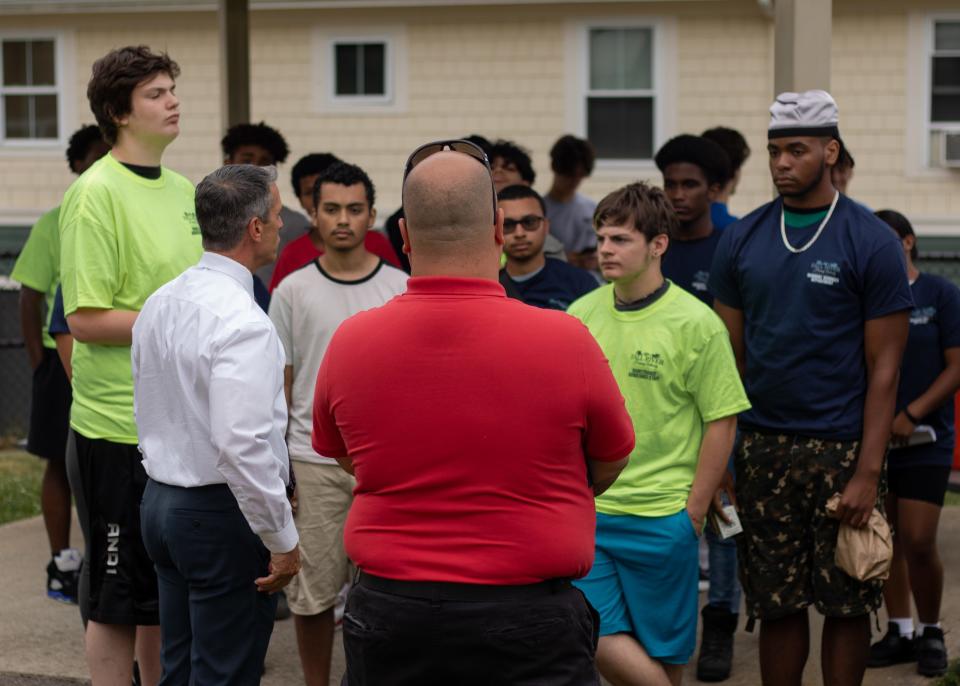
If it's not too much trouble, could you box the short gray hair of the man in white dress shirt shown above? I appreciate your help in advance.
[194,164,277,250]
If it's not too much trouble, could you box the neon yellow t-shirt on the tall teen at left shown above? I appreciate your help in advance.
[60,154,203,444]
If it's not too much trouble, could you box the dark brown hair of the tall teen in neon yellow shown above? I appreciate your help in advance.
[87,45,180,145]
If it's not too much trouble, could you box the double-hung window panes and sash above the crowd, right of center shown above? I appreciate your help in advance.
[586,26,657,160]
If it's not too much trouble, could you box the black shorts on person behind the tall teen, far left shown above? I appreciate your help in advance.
[27,348,72,460]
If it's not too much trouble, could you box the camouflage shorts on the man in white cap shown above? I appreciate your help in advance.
[734,431,885,619]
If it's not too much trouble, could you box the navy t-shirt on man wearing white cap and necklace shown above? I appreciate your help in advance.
[710,195,913,440]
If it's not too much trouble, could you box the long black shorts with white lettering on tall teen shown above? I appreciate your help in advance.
[74,432,160,625]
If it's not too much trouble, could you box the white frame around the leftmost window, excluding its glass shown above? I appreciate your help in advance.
[0,29,74,153]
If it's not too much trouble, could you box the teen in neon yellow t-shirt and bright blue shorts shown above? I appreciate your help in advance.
[568,183,750,683]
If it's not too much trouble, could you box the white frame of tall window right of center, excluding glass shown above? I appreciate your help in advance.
[565,15,676,175]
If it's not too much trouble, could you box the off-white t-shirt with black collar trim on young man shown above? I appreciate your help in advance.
[270,260,407,464]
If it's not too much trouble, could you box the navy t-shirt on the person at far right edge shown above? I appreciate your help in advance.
[887,274,960,467]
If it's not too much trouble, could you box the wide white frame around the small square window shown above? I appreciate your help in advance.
[312,26,407,114]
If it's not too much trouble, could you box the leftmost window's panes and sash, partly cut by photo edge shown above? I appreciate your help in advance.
[0,37,61,142]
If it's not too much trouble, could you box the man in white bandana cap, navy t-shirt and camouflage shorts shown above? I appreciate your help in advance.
[709,90,912,686]
